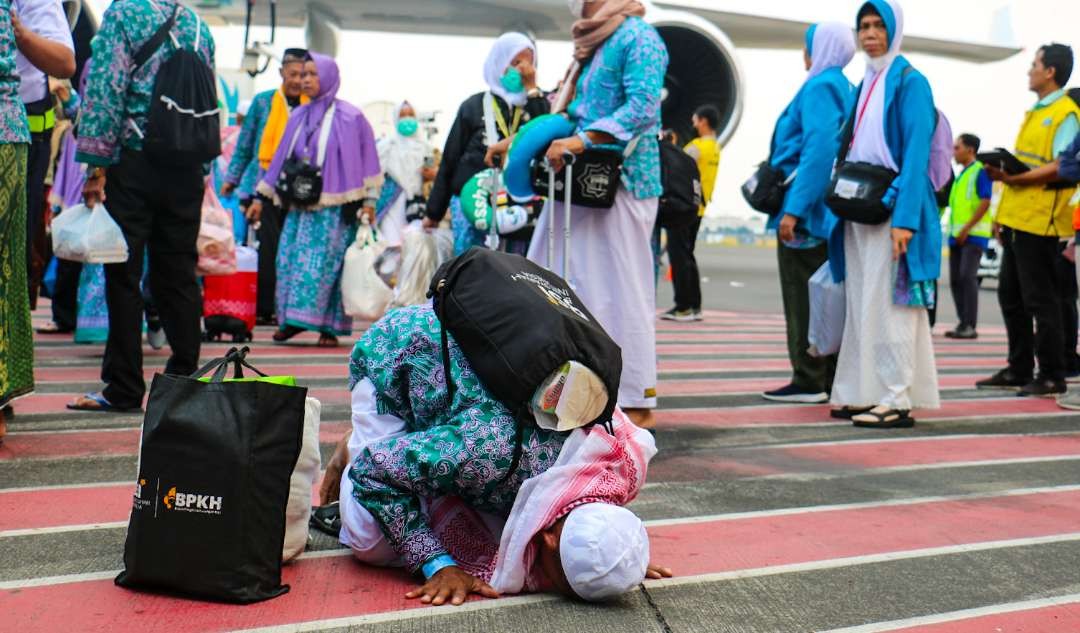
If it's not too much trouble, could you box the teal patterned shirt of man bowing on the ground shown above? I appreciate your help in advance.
[349,304,566,571]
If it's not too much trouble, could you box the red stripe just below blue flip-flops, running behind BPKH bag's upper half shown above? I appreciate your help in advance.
[0,422,349,462]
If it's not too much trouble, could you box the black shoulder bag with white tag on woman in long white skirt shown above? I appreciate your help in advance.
[825,69,909,225]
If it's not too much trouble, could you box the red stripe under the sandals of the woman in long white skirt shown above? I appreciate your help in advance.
[657,398,1070,428]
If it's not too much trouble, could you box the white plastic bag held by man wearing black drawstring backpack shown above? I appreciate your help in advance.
[52,203,127,264]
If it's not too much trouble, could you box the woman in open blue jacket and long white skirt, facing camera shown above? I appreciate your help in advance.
[829,0,942,429]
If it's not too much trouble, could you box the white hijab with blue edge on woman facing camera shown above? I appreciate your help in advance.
[848,0,904,172]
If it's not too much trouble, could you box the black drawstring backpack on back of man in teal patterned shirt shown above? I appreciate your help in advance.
[133,4,221,165]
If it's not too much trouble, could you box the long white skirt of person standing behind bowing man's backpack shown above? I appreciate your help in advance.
[528,188,659,408]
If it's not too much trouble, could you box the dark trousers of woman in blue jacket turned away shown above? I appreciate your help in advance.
[777,239,836,393]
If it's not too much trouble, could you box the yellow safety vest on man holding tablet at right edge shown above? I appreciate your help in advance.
[996,96,1080,237]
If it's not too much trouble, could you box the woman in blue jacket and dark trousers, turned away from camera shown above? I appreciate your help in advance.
[764,22,855,404]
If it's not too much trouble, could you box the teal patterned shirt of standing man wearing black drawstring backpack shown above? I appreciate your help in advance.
[76,0,214,166]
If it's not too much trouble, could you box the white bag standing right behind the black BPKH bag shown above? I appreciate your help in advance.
[281,398,323,563]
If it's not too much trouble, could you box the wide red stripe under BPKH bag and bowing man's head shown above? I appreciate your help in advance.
[2,486,1080,633]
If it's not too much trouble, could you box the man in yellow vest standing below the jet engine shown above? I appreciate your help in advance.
[661,105,720,321]
